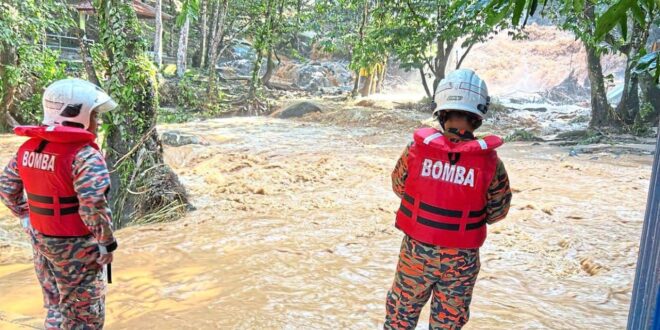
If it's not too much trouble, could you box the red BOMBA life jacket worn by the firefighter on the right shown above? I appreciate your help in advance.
[396,128,503,249]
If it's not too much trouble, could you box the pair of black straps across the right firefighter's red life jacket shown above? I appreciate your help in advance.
[399,193,486,231]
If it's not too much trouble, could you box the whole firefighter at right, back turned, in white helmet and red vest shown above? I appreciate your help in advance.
[385,70,511,329]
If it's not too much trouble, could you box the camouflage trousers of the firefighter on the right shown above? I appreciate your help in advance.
[385,235,480,329]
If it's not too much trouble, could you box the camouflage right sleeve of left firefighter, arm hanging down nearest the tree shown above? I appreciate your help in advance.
[73,146,116,246]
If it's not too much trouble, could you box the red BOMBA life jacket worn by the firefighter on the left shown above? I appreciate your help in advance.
[14,126,98,237]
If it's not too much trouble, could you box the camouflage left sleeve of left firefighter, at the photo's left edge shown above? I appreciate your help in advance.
[0,156,29,218]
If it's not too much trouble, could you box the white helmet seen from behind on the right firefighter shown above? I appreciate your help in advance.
[433,69,490,120]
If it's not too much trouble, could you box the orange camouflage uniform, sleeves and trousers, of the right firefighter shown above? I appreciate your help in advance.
[384,135,511,329]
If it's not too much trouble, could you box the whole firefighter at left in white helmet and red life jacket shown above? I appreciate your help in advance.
[0,79,117,329]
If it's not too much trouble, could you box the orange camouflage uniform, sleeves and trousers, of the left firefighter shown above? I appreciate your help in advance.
[0,146,116,329]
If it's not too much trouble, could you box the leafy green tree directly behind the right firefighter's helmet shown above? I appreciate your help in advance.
[369,0,508,97]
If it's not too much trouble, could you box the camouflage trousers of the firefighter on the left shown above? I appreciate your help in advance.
[30,230,105,330]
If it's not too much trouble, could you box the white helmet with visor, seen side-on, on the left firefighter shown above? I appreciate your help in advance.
[43,78,117,129]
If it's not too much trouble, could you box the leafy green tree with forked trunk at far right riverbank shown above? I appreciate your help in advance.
[487,0,660,127]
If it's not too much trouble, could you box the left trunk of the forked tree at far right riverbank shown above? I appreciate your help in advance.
[584,43,615,127]
